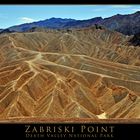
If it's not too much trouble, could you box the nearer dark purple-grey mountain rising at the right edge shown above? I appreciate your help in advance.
[100,11,140,35]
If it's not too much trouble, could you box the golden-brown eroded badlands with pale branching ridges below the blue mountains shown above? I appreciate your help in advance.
[0,9,140,121]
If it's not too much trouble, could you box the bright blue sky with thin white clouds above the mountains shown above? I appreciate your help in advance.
[0,5,140,29]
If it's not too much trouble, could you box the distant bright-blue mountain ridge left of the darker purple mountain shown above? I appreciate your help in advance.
[6,17,102,32]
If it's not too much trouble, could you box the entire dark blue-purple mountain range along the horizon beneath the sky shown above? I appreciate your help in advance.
[0,11,140,35]
